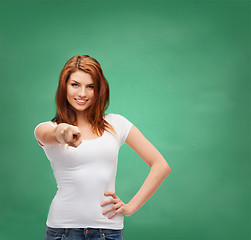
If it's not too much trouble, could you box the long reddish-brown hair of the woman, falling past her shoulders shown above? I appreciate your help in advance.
[51,55,116,136]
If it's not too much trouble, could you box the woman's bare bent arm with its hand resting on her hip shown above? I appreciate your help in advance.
[102,125,171,218]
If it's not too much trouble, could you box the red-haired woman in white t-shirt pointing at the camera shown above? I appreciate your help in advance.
[34,55,171,240]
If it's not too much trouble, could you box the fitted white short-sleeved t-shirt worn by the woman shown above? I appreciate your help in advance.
[34,113,133,229]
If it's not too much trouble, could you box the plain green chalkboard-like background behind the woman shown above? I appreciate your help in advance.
[0,0,251,240]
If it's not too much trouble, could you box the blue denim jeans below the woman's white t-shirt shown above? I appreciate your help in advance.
[44,226,123,240]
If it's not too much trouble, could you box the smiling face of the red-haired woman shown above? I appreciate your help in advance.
[66,70,94,112]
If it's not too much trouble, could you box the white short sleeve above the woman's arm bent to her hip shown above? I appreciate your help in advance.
[114,114,133,146]
